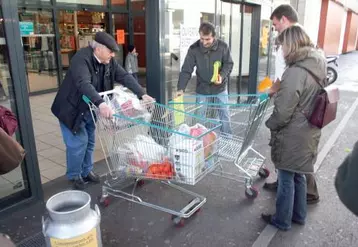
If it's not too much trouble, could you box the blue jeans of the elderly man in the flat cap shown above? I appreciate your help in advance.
[60,112,96,180]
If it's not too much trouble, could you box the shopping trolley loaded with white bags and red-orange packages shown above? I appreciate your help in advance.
[83,91,221,225]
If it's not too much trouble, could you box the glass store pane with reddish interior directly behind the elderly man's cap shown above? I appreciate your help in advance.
[58,10,107,74]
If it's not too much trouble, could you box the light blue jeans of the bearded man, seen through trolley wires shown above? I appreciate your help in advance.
[196,91,232,135]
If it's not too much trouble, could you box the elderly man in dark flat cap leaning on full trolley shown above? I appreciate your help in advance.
[51,32,153,190]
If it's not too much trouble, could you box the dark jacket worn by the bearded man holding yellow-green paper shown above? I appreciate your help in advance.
[178,39,234,95]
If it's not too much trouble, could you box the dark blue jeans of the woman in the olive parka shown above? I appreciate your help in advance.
[271,170,307,230]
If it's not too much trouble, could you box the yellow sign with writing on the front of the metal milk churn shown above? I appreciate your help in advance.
[50,228,98,247]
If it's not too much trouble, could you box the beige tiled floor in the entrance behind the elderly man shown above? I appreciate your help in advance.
[30,93,103,183]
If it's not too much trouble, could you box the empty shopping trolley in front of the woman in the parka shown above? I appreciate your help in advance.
[169,94,270,198]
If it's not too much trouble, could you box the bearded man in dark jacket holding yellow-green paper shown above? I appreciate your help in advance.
[176,22,234,134]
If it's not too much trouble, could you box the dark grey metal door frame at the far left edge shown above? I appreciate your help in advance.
[0,0,43,215]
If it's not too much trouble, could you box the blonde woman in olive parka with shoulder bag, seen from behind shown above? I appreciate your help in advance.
[262,25,327,230]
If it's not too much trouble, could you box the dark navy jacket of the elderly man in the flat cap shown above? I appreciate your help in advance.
[51,47,144,134]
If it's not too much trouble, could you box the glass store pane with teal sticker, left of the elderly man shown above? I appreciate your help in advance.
[19,9,58,93]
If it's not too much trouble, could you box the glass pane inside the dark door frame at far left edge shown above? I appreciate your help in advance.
[0,7,30,208]
